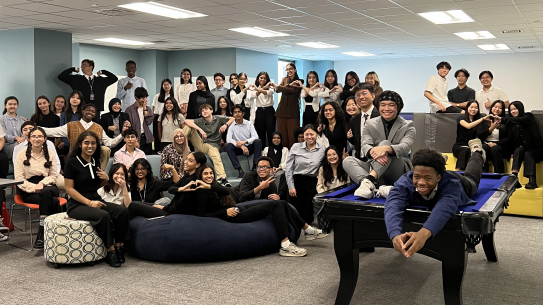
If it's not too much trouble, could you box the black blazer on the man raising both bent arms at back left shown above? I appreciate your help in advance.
[58,68,118,115]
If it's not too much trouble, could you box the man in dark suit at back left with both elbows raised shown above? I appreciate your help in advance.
[58,59,117,115]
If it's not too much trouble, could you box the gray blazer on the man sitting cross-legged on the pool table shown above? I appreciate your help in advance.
[361,116,417,164]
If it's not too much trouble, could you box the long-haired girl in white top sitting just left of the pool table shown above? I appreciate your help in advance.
[317,146,350,193]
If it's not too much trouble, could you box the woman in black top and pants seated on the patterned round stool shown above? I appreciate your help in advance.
[64,130,130,267]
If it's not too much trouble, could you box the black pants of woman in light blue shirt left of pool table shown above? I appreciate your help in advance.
[287,175,317,224]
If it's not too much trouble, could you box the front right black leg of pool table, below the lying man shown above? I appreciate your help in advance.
[441,234,468,305]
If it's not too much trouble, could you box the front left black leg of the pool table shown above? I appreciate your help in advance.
[334,220,359,305]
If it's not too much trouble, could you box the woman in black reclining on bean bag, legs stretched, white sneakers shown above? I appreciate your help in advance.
[192,164,328,256]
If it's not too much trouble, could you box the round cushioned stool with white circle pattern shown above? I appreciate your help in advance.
[43,213,106,268]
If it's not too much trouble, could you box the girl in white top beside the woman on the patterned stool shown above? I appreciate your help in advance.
[98,163,132,206]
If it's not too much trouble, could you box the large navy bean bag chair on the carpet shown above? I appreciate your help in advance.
[128,203,301,263]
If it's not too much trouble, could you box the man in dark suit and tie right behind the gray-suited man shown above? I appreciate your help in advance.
[348,83,379,159]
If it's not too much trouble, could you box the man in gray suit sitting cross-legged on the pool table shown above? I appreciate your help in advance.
[343,91,416,199]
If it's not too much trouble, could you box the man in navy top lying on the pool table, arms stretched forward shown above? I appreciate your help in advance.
[385,139,486,257]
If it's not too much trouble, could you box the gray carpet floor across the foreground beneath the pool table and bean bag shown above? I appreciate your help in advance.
[0,216,543,305]
